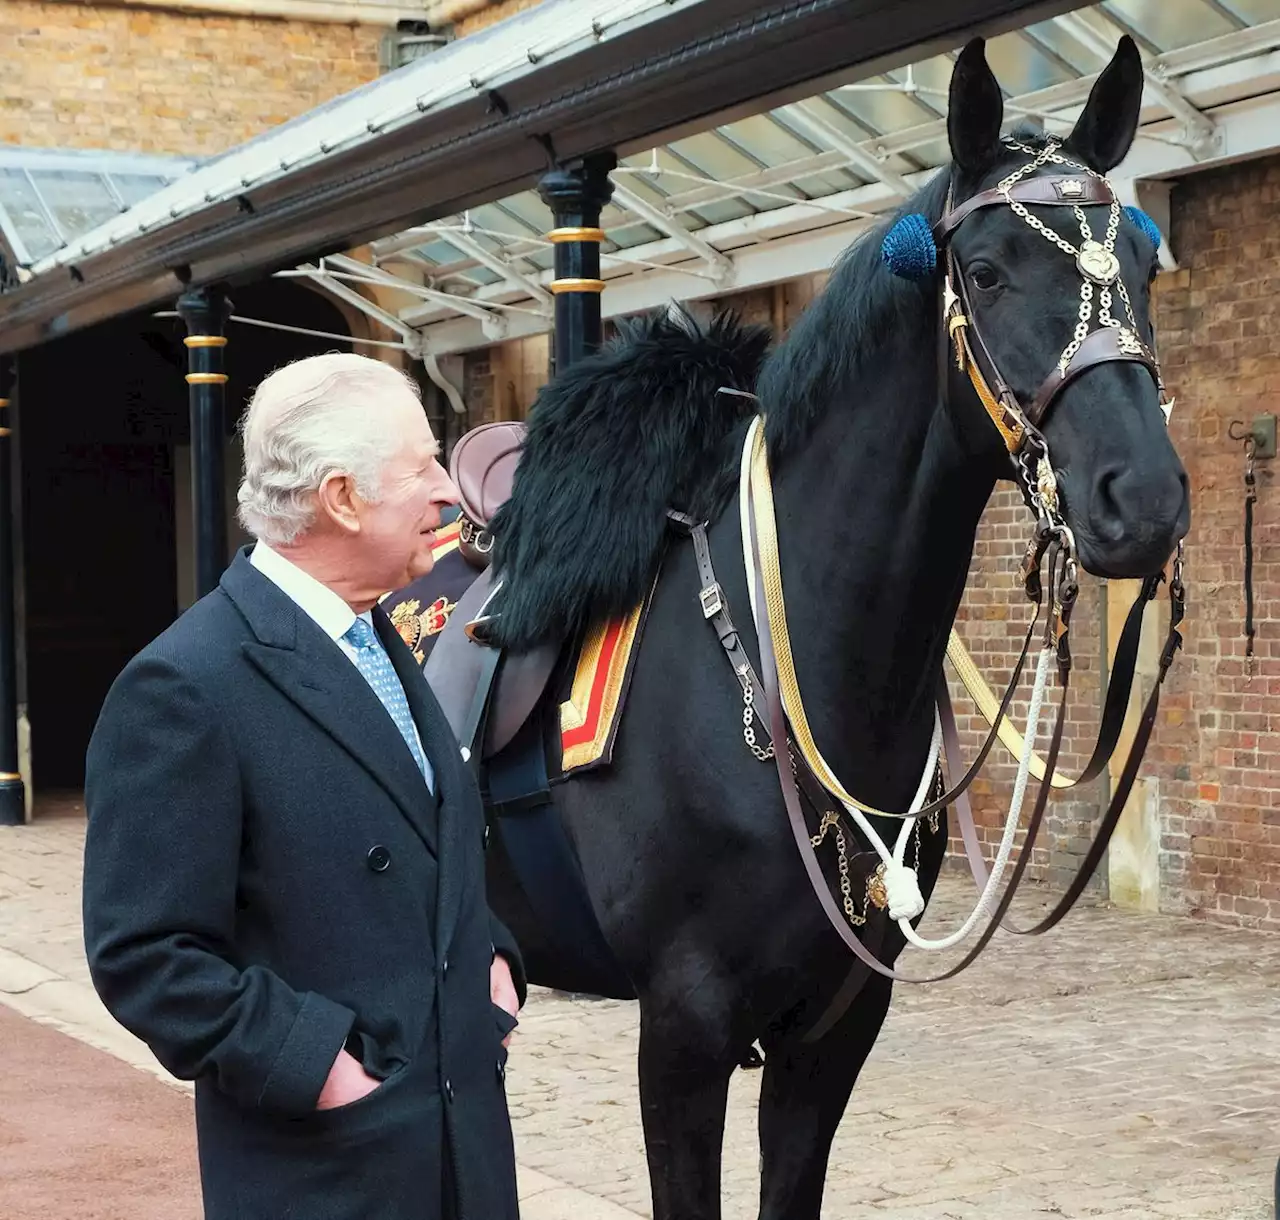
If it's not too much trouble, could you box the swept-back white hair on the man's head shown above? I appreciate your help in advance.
[237,352,419,545]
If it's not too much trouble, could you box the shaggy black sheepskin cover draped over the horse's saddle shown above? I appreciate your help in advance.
[492,312,772,652]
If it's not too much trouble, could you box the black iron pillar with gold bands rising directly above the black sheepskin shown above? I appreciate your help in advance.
[538,152,618,373]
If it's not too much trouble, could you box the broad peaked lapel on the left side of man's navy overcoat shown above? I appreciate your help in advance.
[221,550,439,855]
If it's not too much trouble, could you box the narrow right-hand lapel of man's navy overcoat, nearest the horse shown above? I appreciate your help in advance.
[374,607,483,952]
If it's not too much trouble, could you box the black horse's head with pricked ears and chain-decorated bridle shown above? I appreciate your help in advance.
[936,37,1190,576]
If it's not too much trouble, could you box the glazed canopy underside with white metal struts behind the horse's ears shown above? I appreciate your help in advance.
[337,0,1280,343]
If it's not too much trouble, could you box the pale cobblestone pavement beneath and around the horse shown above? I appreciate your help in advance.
[0,805,1280,1220]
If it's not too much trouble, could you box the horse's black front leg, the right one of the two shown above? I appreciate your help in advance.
[760,975,892,1220]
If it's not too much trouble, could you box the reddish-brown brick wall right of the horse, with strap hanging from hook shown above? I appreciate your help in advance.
[1156,157,1280,928]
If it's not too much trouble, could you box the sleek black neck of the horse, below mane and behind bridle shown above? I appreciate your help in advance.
[776,335,992,808]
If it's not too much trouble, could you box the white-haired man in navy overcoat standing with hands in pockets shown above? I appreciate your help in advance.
[84,355,524,1220]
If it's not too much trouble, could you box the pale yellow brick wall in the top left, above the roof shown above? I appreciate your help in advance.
[0,0,381,156]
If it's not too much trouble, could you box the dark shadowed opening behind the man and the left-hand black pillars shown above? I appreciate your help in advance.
[18,280,349,795]
